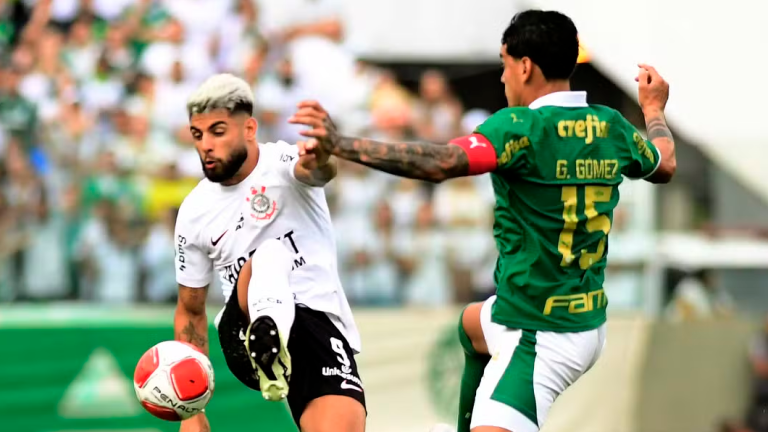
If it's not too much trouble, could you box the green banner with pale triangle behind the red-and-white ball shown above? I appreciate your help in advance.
[0,306,296,432]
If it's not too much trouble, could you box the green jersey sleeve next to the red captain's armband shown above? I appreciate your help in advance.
[475,108,536,171]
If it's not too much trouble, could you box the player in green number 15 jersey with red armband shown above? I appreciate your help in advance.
[290,11,676,432]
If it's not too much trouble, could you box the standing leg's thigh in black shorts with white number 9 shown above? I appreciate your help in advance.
[288,306,366,431]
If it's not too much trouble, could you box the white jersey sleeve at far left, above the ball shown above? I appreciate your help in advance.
[174,205,213,288]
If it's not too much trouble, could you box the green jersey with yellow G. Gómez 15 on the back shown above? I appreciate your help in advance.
[475,93,660,332]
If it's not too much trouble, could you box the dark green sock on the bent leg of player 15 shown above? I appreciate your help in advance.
[457,312,491,432]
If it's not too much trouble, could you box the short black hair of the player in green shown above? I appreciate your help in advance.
[501,10,579,80]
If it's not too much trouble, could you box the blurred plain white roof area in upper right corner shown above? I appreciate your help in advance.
[529,0,768,200]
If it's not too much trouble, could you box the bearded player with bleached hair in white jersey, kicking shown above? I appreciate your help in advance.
[174,74,366,432]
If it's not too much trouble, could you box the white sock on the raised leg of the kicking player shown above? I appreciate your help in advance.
[248,239,296,345]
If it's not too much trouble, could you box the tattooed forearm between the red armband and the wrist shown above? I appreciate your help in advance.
[335,137,469,182]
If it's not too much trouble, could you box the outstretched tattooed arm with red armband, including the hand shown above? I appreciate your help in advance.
[289,101,496,183]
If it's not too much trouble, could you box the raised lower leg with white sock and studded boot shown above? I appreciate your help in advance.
[237,240,296,400]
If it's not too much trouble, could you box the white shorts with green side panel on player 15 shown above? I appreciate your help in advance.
[470,296,605,432]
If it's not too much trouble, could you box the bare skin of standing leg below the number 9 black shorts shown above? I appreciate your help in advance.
[300,395,365,432]
